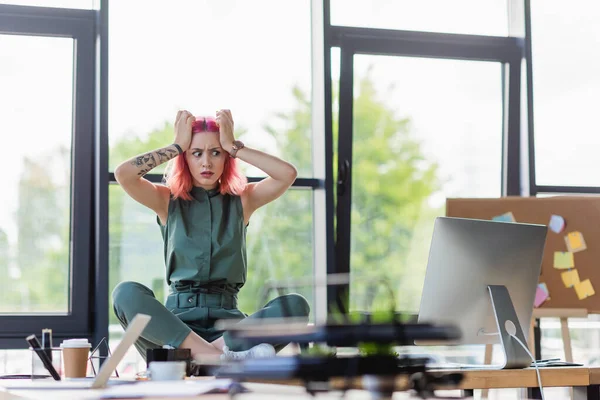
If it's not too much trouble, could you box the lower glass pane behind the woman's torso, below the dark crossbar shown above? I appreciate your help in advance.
[109,185,314,375]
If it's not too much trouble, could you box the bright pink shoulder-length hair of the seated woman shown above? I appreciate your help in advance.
[165,117,248,201]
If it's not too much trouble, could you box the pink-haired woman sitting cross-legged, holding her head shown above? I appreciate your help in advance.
[112,110,310,359]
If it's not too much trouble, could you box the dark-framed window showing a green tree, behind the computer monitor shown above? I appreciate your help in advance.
[332,11,521,363]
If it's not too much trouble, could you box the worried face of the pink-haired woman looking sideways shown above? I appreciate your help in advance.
[186,132,229,190]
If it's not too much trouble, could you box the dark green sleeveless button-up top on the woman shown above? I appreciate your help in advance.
[157,187,247,292]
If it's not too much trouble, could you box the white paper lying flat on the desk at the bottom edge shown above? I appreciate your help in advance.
[101,379,237,399]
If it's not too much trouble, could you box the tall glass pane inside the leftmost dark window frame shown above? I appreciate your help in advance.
[0,35,73,313]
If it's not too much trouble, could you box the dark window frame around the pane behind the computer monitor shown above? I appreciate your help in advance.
[324,0,526,310]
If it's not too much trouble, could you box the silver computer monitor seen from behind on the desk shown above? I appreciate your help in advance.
[418,217,548,368]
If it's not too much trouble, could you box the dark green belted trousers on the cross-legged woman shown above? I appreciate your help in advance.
[112,282,310,360]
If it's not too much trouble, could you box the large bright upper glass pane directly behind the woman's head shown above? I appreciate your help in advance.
[109,0,312,177]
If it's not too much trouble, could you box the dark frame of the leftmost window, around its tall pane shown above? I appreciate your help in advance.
[0,5,97,349]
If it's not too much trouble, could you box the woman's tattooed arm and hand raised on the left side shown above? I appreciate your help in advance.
[115,111,194,225]
